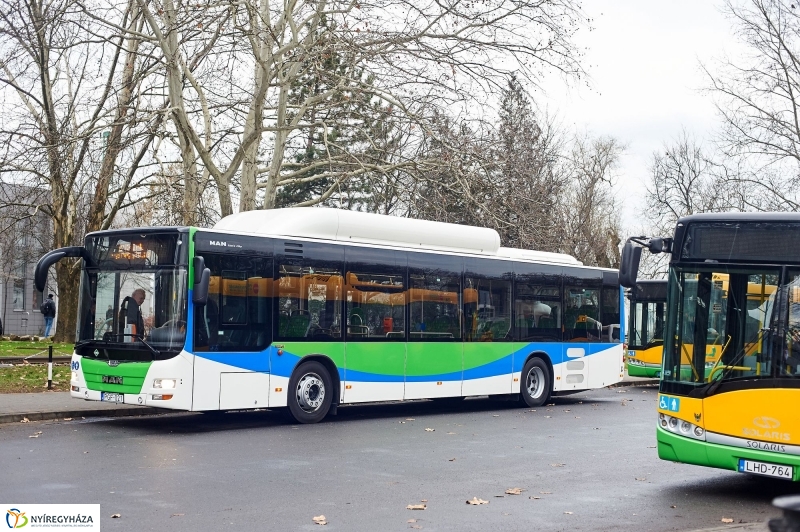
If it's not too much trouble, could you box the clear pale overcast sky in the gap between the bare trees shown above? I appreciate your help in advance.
[535,0,738,234]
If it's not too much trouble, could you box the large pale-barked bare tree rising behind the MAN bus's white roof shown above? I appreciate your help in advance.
[138,0,583,215]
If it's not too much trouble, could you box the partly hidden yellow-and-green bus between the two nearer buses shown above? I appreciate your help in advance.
[626,280,667,378]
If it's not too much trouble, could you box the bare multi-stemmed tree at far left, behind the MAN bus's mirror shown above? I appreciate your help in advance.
[0,0,161,340]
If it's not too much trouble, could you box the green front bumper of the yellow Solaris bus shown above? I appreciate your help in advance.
[656,427,800,482]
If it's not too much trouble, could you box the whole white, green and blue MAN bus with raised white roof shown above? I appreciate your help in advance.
[36,208,623,423]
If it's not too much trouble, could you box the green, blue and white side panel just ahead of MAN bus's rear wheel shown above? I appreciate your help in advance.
[461,342,519,396]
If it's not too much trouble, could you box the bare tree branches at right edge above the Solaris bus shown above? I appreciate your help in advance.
[703,0,800,210]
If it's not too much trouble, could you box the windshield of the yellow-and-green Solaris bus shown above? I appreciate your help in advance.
[663,266,800,393]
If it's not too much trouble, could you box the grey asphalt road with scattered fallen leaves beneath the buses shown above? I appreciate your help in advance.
[0,387,800,532]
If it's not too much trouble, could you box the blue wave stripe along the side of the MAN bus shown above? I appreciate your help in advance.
[195,342,619,382]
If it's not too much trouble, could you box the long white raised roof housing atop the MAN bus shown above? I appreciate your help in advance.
[212,207,582,266]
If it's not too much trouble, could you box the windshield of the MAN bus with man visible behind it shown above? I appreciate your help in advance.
[77,234,187,356]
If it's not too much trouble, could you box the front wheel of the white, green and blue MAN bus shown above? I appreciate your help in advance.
[287,360,333,423]
